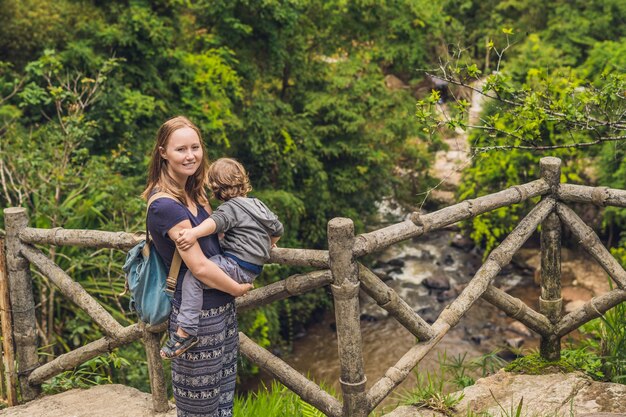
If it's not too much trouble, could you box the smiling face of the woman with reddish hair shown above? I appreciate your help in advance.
[159,127,204,187]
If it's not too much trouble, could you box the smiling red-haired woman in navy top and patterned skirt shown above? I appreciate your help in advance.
[143,116,252,417]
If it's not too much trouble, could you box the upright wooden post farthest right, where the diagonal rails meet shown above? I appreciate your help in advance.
[539,157,563,360]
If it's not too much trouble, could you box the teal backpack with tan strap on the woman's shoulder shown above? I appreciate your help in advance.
[122,193,181,325]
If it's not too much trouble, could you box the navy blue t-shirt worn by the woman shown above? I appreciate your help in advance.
[147,198,234,310]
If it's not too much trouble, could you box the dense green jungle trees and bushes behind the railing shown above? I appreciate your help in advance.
[0,0,626,389]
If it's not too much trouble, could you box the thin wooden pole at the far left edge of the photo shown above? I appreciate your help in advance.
[0,239,17,407]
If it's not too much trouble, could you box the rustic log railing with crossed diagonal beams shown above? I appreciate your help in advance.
[4,157,626,417]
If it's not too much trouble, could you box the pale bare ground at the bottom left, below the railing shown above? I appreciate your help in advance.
[0,384,176,417]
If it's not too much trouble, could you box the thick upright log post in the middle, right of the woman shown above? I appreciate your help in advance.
[328,218,369,417]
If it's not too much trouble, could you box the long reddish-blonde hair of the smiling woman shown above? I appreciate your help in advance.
[141,116,209,205]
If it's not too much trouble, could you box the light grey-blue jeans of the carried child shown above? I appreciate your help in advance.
[178,255,258,336]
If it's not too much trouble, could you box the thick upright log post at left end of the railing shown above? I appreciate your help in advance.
[4,207,40,401]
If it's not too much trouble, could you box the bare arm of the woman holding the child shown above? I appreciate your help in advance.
[167,220,252,297]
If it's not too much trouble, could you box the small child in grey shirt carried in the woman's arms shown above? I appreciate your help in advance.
[161,158,283,359]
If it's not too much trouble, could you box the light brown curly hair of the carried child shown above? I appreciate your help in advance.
[207,158,252,201]
